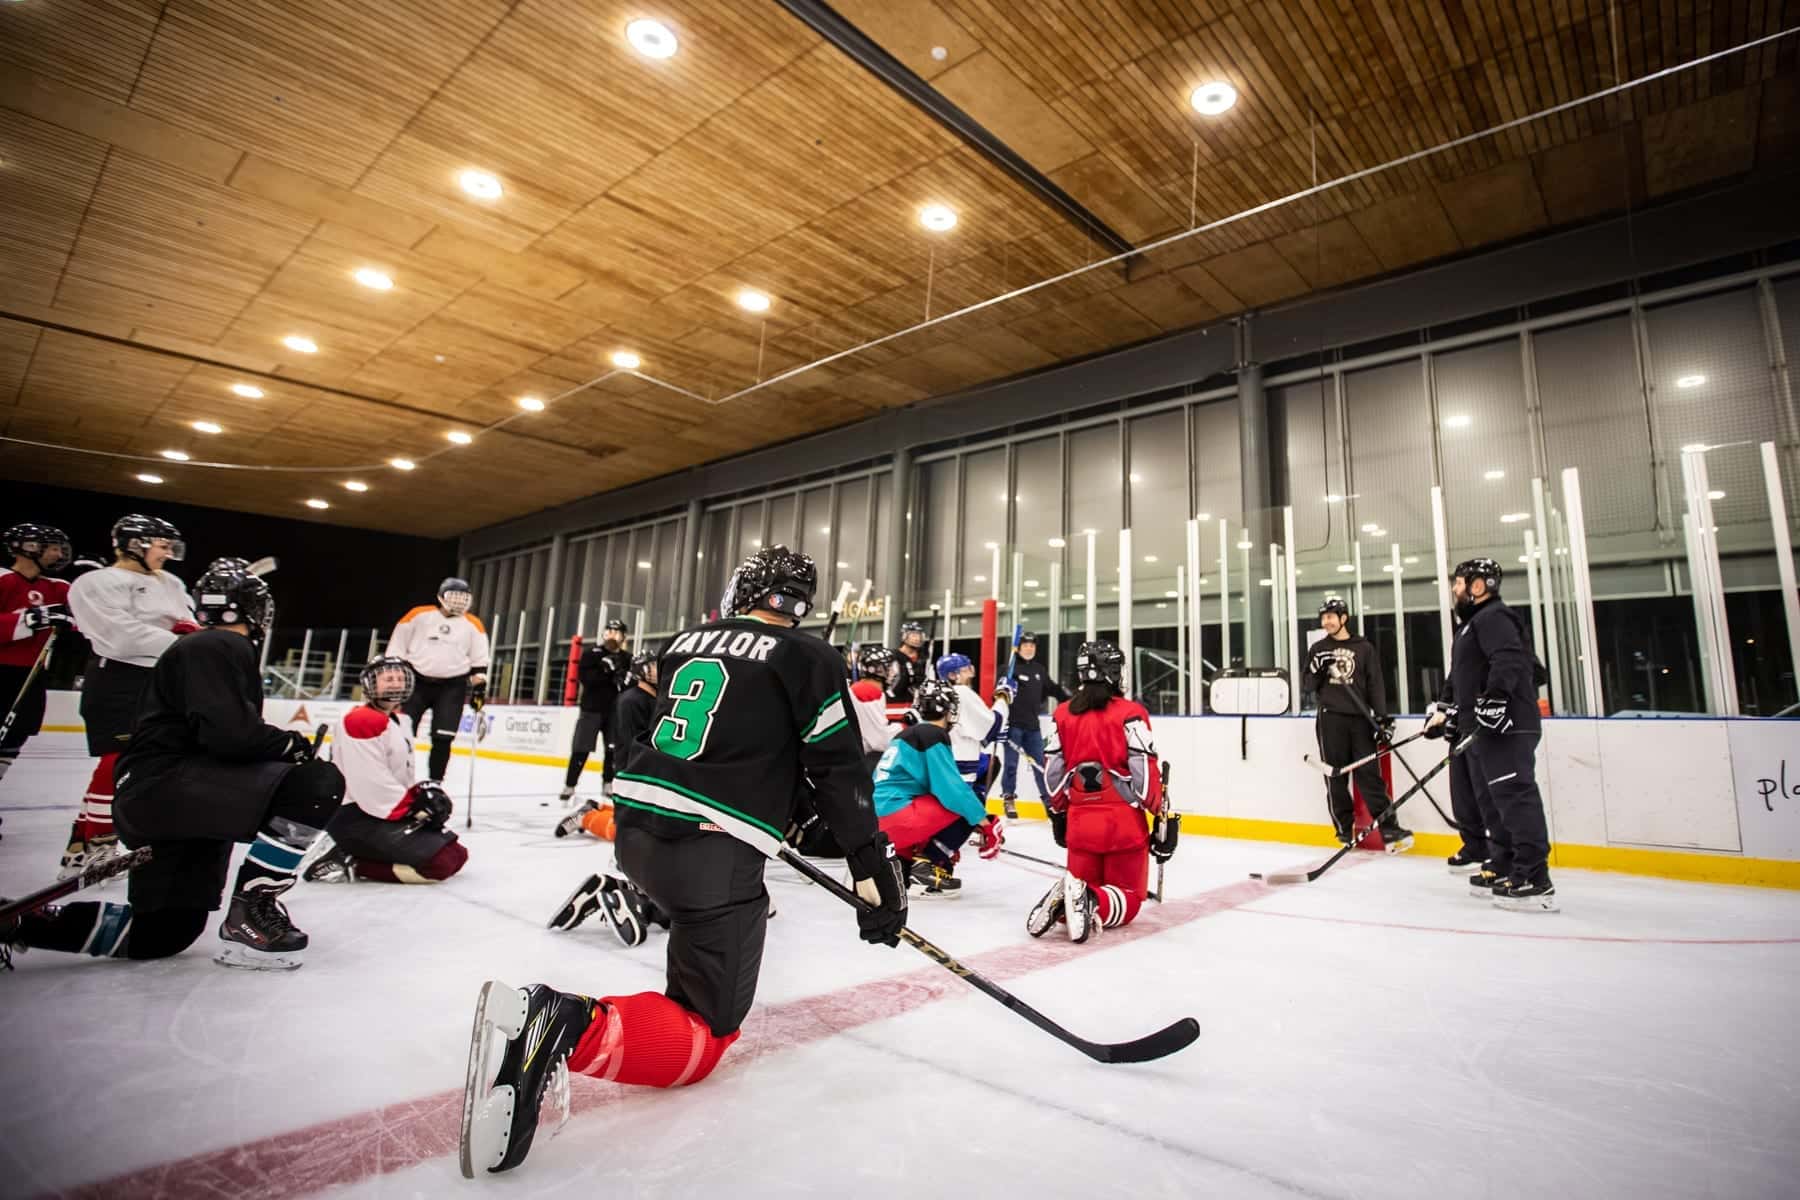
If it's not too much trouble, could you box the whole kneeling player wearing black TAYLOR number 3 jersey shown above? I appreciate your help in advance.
[461,547,905,1175]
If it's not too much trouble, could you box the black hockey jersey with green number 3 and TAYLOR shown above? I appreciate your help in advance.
[612,617,877,856]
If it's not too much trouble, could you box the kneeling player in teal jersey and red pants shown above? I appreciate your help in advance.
[875,680,1006,898]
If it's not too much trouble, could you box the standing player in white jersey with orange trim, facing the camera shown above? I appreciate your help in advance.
[387,578,488,783]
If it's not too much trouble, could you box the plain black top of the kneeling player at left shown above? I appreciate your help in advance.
[117,630,290,790]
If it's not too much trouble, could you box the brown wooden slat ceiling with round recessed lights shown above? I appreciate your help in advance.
[0,0,1800,536]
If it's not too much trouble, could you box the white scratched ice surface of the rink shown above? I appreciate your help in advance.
[0,734,1800,1200]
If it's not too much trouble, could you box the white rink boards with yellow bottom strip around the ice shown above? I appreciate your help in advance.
[35,693,1800,889]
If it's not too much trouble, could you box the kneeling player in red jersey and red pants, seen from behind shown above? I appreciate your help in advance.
[1024,640,1181,941]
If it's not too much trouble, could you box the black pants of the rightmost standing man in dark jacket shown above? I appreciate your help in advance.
[1451,732,1550,880]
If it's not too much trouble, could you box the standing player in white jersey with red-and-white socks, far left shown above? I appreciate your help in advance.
[59,515,200,878]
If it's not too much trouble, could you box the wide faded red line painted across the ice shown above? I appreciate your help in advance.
[54,880,1273,1200]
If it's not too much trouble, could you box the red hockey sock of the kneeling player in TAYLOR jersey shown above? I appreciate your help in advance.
[569,991,738,1087]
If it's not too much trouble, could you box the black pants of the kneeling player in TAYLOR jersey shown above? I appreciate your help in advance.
[614,826,769,1038]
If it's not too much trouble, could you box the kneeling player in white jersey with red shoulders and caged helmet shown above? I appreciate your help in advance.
[304,657,468,883]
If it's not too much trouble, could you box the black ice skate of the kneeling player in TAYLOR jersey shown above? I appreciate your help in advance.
[457,979,599,1178]
